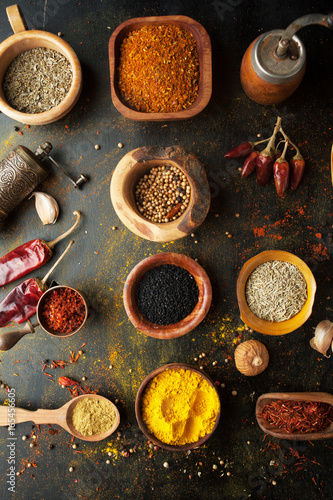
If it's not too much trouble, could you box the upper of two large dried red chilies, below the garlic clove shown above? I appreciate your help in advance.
[0,210,81,286]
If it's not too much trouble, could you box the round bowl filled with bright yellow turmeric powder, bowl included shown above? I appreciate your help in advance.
[135,363,221,451]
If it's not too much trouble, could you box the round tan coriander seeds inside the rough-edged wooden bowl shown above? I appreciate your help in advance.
[135,165,191,223]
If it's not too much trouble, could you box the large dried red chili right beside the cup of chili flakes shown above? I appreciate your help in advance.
[0,240,74,328]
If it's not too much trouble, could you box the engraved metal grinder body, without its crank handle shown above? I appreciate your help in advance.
[0,142,48,230]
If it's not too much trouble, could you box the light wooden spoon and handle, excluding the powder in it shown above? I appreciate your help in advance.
[0,394,120,441]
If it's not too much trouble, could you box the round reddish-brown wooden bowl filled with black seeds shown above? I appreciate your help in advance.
[123,253,212,339]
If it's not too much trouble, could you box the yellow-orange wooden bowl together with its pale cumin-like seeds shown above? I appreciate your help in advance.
[237,250,317,335]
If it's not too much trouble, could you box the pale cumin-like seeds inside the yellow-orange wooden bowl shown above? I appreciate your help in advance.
[245,260,307,322]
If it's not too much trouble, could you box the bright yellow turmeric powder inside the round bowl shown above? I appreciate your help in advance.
[141,369,220,446]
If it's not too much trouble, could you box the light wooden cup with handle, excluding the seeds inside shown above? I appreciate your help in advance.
[0,5,82,125]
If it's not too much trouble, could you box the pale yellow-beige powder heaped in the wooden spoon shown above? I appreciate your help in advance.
[72,397,116,436]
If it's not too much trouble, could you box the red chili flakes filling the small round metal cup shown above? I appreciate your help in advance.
[41,288,86,333]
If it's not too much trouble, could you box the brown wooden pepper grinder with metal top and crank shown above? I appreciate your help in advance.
[241,13,333,105]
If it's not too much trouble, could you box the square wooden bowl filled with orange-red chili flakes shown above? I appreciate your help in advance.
[109,16,212,121]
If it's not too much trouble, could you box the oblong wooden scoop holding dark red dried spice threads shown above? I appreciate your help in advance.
[256,392,333,441]
